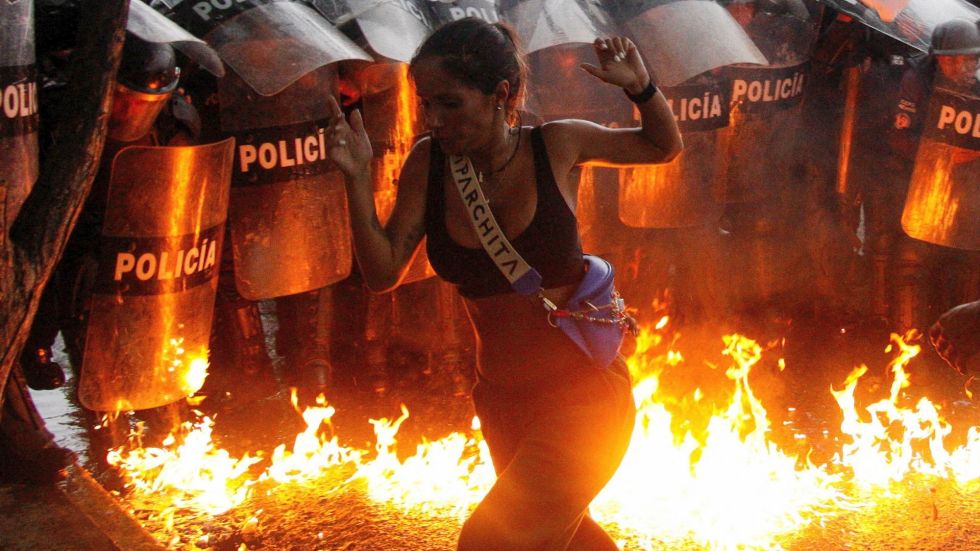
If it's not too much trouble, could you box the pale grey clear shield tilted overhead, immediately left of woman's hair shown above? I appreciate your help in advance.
[347,0,432,63]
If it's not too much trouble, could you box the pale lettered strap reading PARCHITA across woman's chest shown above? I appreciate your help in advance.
[449,155,541,295]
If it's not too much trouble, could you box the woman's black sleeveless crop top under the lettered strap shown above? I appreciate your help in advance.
[425,127,584,298]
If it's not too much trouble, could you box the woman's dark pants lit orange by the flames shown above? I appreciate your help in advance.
[458,357,636,551]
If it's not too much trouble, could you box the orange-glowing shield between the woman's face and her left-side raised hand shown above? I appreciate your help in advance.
[362,63,435,284]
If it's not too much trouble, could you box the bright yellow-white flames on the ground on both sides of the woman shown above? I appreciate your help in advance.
[110,324,980,548]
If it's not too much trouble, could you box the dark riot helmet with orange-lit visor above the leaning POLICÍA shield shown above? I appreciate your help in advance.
[108,32,180,142]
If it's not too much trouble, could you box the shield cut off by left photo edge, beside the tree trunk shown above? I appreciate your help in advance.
[0,0,40,228]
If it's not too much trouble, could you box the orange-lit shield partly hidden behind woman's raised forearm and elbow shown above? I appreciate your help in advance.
[619,76,731,228]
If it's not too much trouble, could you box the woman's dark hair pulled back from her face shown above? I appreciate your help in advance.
[409,17,527,113]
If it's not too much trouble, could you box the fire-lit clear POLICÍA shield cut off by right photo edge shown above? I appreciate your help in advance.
[902,82,980,251]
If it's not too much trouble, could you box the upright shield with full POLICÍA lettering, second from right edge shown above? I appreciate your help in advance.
[724,4,818,203]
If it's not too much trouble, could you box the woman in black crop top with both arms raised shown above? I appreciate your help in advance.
[329,19,682,550]
